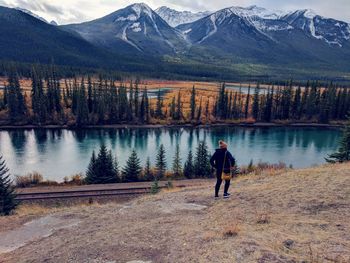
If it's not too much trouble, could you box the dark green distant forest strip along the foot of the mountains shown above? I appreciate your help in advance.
[0,60,350,86]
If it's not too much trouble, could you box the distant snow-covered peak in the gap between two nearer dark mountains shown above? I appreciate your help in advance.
[155,6,211,27]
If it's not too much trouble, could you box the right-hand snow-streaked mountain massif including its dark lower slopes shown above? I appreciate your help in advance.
[177,6,350,67]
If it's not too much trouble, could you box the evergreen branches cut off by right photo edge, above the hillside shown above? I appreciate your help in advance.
[326,120,350,163]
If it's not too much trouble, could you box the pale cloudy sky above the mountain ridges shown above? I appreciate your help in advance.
[0,0,350,24]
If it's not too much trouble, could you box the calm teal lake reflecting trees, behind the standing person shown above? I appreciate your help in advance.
[0,127,341,181]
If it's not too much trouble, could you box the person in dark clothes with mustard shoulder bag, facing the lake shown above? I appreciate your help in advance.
[210,141,236,198]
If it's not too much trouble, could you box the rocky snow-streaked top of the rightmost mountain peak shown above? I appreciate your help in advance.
[281,9,350,47]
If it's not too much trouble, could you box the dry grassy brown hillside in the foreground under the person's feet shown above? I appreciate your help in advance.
[0,164,350,263]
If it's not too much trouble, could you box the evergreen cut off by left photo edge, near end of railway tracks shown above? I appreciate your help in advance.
[0,155,18,216]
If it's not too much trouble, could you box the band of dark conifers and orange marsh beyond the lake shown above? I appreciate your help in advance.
[0,66,350,127]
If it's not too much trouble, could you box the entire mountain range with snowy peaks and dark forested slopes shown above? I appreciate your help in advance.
[0,3,350,80]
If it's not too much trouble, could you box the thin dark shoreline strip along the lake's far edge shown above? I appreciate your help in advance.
[0,122,344,130]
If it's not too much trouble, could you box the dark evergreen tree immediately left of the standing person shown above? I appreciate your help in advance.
[194,141,211,177]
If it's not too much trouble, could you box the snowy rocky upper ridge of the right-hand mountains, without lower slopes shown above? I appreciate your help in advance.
[177,6,350,47]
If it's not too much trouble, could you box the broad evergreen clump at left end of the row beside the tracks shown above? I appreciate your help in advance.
[86,145,119,184]
